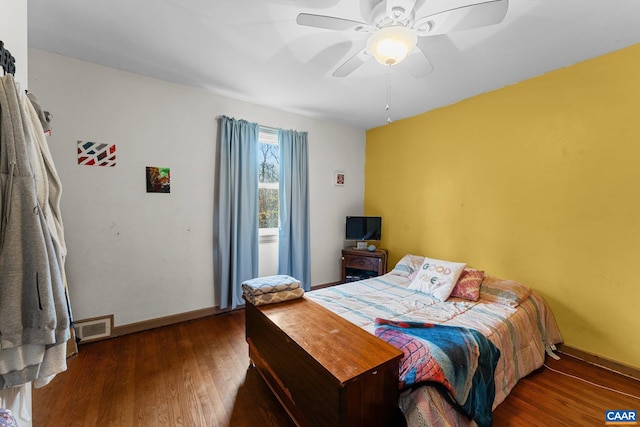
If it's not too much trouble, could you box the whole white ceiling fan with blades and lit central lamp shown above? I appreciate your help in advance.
[296,0,509,78]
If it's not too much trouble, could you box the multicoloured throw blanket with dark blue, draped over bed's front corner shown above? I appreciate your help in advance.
[375,319,500,427]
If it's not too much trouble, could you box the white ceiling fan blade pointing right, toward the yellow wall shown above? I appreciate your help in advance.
[414,0,509,36]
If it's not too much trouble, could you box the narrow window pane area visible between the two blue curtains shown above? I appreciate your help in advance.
[258,127,280,236]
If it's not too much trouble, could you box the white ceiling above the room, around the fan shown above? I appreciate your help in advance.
[28,0,640,129]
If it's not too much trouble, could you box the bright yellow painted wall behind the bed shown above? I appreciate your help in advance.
[365,44,640,367]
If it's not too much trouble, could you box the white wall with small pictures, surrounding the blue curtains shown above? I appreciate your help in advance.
[29,49,365,326]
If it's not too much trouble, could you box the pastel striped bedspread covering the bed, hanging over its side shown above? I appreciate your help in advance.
[305,274,562,427]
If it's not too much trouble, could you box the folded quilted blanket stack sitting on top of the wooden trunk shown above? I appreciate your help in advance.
[242,274,304,305]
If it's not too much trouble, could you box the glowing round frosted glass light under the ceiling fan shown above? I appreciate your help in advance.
[367,26,418,65]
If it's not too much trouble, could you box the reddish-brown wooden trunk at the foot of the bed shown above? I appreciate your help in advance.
[246,298,402,427]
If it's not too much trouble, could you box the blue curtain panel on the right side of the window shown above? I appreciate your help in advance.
[278,129,311,291]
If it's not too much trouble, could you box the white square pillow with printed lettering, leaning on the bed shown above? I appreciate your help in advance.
[407,258,467,301]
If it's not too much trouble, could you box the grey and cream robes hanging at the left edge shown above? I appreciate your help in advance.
[0,74,71,389]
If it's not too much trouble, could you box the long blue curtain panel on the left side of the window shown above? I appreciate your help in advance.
[214,116,259,309]
